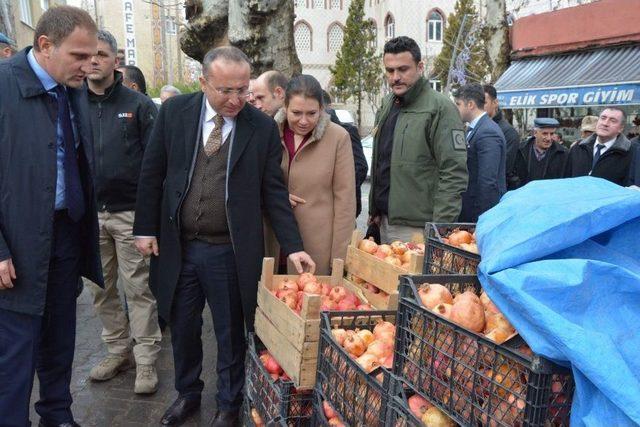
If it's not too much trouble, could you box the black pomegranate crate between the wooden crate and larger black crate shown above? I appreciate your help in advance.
[315,311,396,427]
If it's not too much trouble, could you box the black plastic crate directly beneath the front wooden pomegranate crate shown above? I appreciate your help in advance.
[245,334,313,427]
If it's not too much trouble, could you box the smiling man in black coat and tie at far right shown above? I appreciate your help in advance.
[564,107,635,185]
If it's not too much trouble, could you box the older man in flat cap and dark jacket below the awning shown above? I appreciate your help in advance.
[513,117,569,189]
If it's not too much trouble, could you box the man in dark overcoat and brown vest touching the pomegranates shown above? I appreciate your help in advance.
[134,47,315,426]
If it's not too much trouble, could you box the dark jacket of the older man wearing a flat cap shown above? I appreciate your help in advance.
[508,136,569,190]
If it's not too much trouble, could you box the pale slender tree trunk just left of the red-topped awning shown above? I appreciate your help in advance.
[484,0,511,82]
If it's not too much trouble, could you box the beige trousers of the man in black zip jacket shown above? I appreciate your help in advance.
[91,211,162,364]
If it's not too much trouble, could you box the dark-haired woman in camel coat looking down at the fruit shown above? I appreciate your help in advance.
[268,75,356,275]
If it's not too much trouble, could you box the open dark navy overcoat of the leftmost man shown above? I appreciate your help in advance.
[0,48,103,315]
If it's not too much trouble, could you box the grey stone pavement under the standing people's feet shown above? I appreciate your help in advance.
[31,182,369,427]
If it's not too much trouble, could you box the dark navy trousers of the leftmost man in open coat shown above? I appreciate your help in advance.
[0,210,80,427]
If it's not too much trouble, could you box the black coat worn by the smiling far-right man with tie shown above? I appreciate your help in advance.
[564,134,633,185]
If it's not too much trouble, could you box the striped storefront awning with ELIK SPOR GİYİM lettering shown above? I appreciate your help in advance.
[495,45,640,109]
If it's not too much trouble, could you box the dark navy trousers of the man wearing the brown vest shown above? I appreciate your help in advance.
[170,240,246,411]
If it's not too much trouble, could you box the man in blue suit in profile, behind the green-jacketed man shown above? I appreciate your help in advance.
[455,83,507,222]
